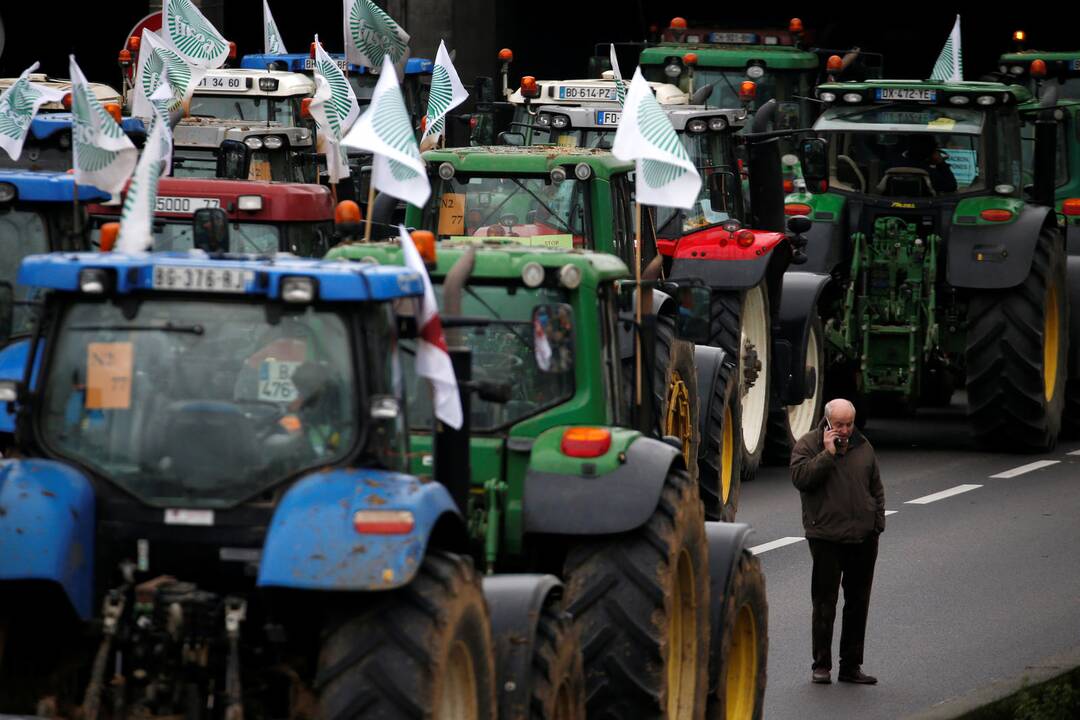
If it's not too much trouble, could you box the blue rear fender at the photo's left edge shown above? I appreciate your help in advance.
[0,460,96,620]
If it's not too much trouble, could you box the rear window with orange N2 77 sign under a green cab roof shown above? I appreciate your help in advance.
[428,171,589,248]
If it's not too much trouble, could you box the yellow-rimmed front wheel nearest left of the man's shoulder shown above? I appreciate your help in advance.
[698,363,742,522]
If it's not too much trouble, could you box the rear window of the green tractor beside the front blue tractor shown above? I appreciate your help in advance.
[402,284,573,432]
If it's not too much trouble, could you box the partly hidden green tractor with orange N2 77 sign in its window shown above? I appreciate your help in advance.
[376,146,756,519]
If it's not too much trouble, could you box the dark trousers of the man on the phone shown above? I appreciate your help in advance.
[807,534,877,673]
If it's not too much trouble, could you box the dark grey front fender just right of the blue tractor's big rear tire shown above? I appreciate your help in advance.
[484,574,563,718]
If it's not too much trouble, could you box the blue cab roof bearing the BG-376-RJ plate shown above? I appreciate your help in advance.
[18,250,423,302]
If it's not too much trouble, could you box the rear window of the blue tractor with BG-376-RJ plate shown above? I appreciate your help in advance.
[40,297,359,507]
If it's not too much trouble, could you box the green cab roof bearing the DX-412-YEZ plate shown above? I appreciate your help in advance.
[816,80,1031,107]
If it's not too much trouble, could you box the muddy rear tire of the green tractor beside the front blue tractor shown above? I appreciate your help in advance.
[564,468,708,720]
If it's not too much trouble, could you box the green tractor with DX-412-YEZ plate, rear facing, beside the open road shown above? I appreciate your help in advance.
[786,80,1080,451]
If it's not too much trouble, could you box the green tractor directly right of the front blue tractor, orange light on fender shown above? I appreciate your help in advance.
[328,239,767,718]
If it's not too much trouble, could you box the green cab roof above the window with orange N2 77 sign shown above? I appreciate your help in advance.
[414,145,634,178]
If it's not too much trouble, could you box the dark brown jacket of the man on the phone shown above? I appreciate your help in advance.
[792,420,885,543]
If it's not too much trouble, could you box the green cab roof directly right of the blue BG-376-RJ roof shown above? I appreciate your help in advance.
[326,241,630,287]
